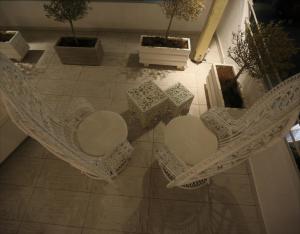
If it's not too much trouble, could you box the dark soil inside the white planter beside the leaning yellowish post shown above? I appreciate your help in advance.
[142,37,188,49]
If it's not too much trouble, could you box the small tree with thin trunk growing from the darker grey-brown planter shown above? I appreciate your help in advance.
[44,0,89,41]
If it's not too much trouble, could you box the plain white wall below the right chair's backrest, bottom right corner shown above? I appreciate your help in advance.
[250,140,300,234]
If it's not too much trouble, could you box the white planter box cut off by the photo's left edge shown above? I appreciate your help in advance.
[0,31,29,61]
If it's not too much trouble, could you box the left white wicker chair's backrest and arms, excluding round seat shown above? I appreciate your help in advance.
[0,54,133,181]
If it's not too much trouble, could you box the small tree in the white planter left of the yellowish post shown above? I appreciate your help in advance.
[160,0,204,39]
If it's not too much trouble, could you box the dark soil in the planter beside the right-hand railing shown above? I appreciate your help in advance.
[216,66,244,108]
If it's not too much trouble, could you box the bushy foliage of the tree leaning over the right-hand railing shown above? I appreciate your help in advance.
[228,22,299,79]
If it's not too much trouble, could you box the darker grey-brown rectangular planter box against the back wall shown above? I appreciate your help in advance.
[54,38,103,66]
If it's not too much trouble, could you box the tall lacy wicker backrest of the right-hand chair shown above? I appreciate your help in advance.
[168,73,300,187]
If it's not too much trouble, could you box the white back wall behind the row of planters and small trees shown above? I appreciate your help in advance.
[0,0,212,32]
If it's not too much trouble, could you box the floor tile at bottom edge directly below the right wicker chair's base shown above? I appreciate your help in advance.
[149,199,211,234]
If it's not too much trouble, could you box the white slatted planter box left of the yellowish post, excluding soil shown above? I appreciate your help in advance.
[139,35,191,70]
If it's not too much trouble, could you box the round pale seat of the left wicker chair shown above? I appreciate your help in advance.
[77,111,128,156]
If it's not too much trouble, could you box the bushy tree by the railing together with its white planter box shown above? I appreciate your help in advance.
[207,22,298,108]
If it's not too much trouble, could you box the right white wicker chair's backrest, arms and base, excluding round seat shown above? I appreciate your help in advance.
[155,73,300,189]
